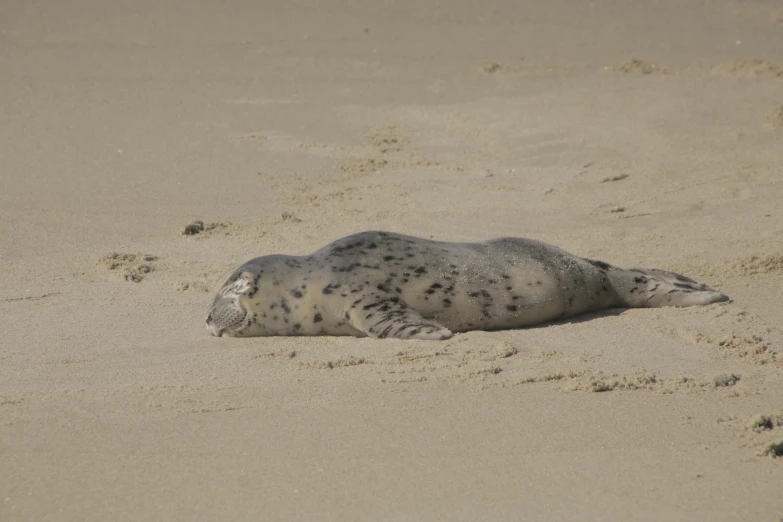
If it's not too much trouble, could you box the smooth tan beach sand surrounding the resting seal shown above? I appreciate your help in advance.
[0,0,783,522]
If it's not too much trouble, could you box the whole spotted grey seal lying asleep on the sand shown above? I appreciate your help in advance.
[207,231,729,340]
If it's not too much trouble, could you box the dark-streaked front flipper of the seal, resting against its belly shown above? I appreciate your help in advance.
[345,293,452,341]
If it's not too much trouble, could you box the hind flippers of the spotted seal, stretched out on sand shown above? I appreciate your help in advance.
[607,268,729,308]
